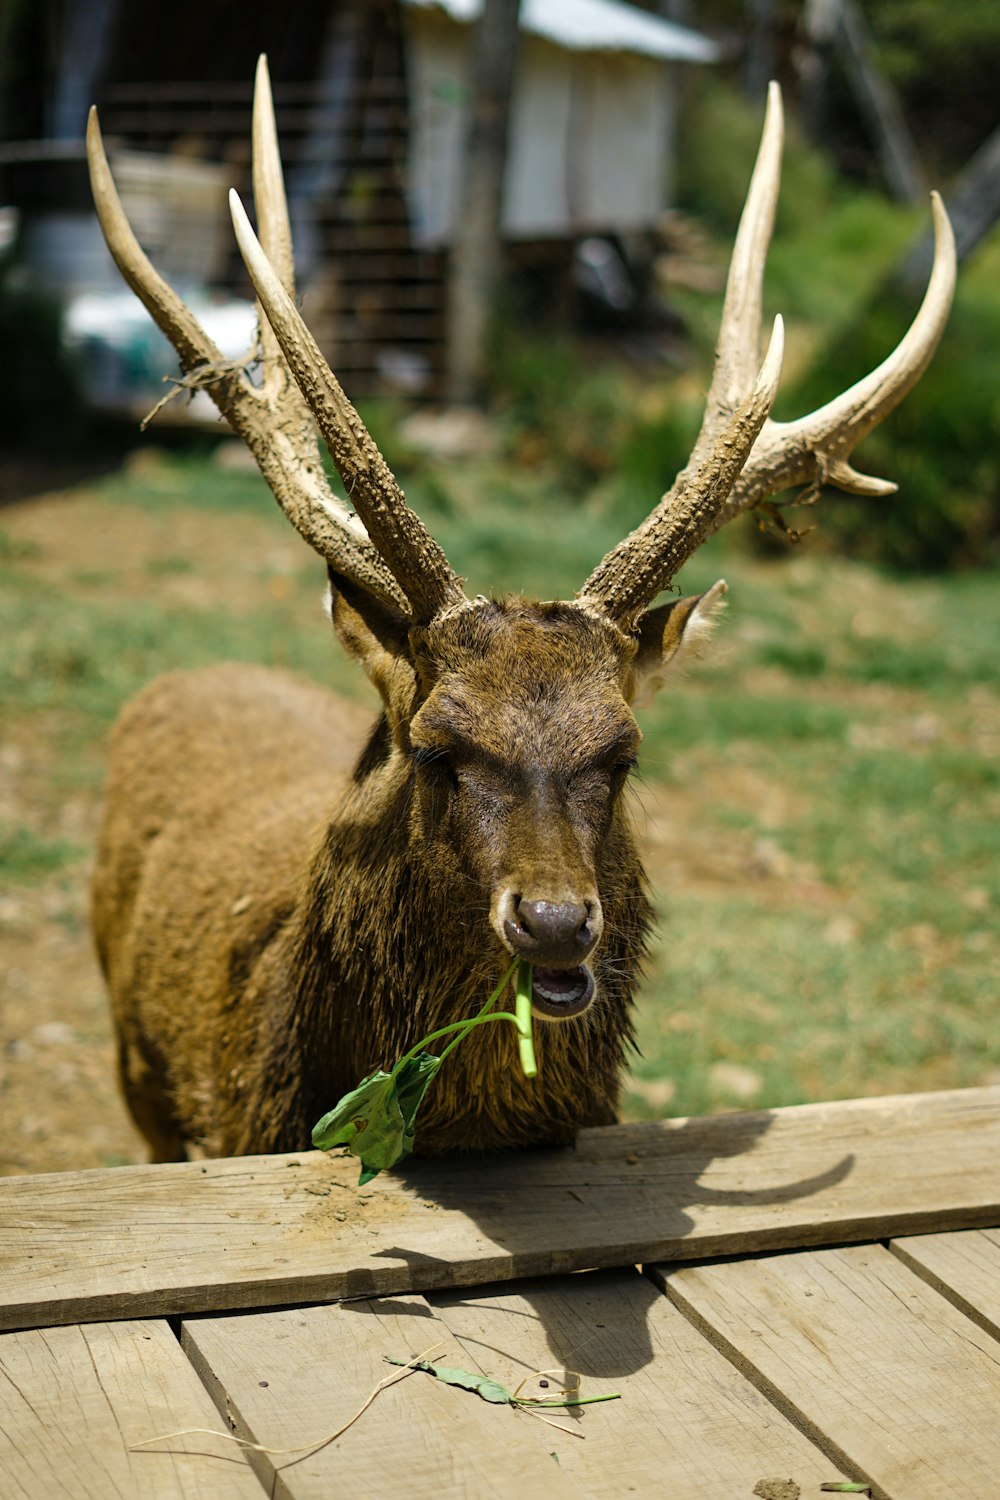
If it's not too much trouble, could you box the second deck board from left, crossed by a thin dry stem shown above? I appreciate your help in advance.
[183,1296,580,1500]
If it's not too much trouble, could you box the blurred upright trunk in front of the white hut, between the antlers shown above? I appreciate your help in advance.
[445,0,520,405]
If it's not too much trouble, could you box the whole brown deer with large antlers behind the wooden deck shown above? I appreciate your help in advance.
[87,59,955,1161]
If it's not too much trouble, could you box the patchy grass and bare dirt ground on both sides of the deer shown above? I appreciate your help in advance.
[0,444,1000,1116]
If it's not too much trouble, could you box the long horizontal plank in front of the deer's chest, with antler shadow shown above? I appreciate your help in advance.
[0,1088,1000,1328]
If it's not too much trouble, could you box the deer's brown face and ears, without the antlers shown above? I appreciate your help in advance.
[330,575,724,1019]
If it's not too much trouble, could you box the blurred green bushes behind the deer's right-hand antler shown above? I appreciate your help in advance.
[482,81,1000,570]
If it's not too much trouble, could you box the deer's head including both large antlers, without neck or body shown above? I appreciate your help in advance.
[88,62,955,1019]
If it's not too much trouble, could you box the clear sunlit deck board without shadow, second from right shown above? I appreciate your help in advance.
[658,1245,1000,1500]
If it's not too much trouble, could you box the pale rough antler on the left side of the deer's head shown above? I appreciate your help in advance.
[87,57,465,620]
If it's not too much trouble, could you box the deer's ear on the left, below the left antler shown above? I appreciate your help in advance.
[327,569,417,735]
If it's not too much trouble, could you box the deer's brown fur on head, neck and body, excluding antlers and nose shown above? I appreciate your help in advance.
[93,579,719,1160]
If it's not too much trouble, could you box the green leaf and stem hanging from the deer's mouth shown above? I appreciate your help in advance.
[312,959,538,1187]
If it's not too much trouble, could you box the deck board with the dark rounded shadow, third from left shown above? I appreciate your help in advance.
[432,1271,840,1500]
